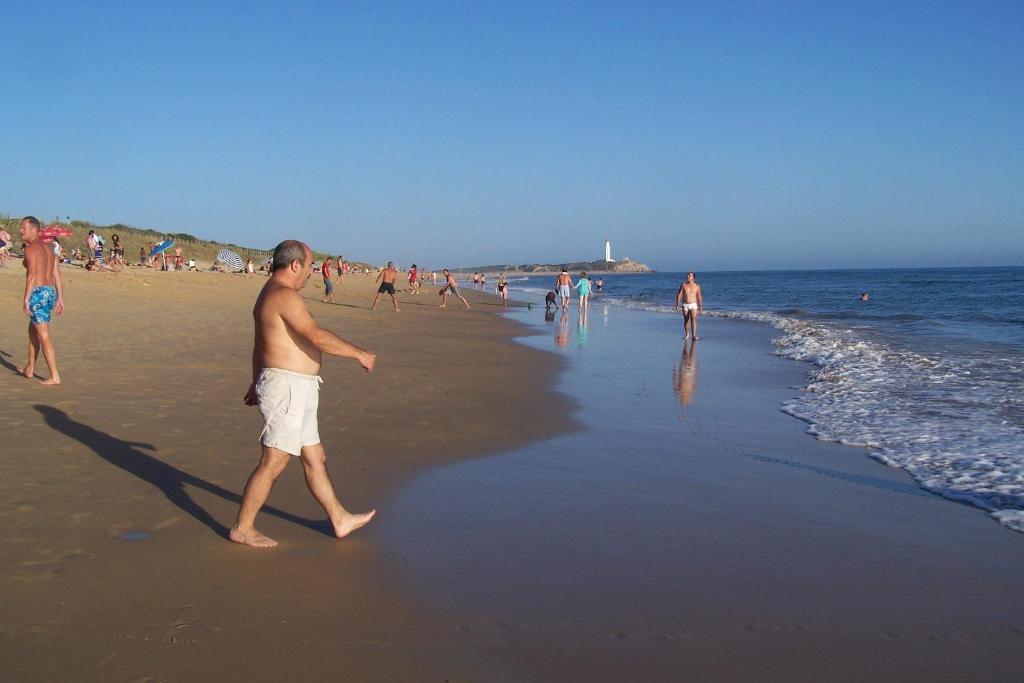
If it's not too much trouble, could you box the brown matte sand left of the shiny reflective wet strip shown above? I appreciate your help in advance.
[0,261,566,680]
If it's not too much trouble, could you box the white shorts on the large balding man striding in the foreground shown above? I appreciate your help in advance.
[256,368,324,456]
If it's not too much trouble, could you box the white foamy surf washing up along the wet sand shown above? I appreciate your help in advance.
[516,288,1024,532]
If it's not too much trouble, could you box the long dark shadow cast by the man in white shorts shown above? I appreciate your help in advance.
[34,404,333,538]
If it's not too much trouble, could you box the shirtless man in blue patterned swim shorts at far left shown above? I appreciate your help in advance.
[17,216,63,385]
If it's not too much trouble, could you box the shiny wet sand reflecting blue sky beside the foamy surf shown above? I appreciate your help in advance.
[380,306,1024,681]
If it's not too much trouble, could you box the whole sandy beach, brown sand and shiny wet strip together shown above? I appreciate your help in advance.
[0,268,1024,681]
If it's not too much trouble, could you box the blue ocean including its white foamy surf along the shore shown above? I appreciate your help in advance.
[510,267,1024,531]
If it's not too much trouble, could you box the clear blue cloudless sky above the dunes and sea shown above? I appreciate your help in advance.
[0,0,1024,270]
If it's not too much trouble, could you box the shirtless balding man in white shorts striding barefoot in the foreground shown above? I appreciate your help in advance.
[228,240,377,548]
